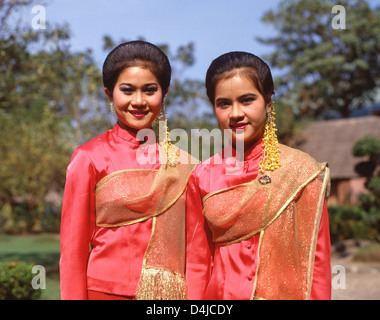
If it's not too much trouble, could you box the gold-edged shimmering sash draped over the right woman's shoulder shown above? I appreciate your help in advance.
[203,145,329,299]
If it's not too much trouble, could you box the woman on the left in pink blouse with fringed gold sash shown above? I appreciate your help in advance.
[60,41,193,299]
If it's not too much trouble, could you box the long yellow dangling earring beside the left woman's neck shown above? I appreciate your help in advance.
[155,100,179,167]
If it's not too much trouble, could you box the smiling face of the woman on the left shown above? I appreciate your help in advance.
[105,67,164,131]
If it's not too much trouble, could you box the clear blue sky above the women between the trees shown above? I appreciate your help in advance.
[29,0,280,80]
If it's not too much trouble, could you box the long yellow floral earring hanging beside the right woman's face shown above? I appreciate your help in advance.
[259,102,281,173]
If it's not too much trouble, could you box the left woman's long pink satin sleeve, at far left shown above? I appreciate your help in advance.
[60,148,95,300]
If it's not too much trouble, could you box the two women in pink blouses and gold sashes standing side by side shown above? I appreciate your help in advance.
[60,41,330,299]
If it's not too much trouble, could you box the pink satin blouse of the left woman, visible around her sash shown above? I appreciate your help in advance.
[60,124,160,299]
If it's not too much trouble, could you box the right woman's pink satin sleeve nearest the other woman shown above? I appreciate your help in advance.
[186,170,212,300]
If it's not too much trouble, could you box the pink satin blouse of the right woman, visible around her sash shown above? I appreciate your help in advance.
[186,140,331,300]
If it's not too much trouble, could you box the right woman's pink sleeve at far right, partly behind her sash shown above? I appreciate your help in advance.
[310,201,331,300]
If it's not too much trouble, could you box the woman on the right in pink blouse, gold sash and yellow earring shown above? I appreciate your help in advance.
[186,52,331,300]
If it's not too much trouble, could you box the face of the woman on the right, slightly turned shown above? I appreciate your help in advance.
[214,75,270,150]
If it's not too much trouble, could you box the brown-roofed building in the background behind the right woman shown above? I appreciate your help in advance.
[291,115,380,205]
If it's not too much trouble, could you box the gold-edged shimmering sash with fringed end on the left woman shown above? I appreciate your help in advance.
[96,151,195,300]
